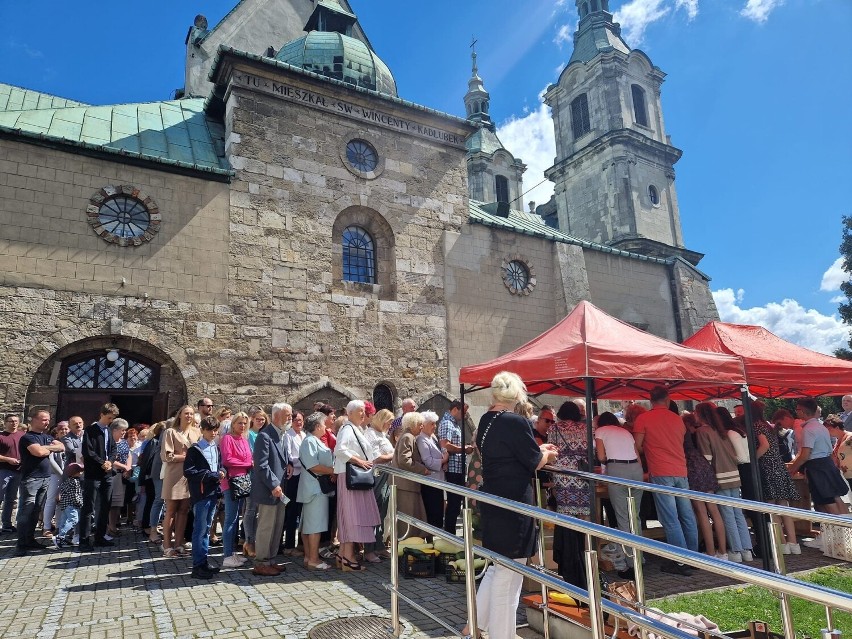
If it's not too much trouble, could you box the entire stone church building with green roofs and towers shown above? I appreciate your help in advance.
[0,0,716,421]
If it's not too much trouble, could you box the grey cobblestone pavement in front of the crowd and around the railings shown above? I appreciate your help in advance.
[0,532,837,639]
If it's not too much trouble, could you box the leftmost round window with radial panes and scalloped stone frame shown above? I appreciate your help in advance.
[86,185,161,246]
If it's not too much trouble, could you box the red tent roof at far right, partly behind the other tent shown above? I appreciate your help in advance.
[684,322,852,397]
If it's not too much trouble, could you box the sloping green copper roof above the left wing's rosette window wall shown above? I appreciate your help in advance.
[0,98,229,173]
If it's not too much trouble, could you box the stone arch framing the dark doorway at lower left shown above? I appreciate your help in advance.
[18,319,195,417]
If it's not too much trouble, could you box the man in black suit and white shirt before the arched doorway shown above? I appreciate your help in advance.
[80,404,118,552]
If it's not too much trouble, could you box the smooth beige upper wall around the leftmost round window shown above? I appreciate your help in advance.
[0,140,228,304]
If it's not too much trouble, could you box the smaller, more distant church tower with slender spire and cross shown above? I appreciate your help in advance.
[464,45,527,212]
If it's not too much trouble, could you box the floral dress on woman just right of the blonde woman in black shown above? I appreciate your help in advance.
[547,419,590,517]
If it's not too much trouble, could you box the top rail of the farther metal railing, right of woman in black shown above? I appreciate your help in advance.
[543,465,852,528]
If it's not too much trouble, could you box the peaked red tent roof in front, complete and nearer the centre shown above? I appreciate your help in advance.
[459,301,745,399]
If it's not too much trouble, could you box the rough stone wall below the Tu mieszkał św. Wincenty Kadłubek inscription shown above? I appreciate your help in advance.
[218,60,467,410]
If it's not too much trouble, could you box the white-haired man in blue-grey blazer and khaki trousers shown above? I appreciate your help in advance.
[251,402,293,577]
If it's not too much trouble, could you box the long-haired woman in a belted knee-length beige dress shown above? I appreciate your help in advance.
[160,405,201,557]
